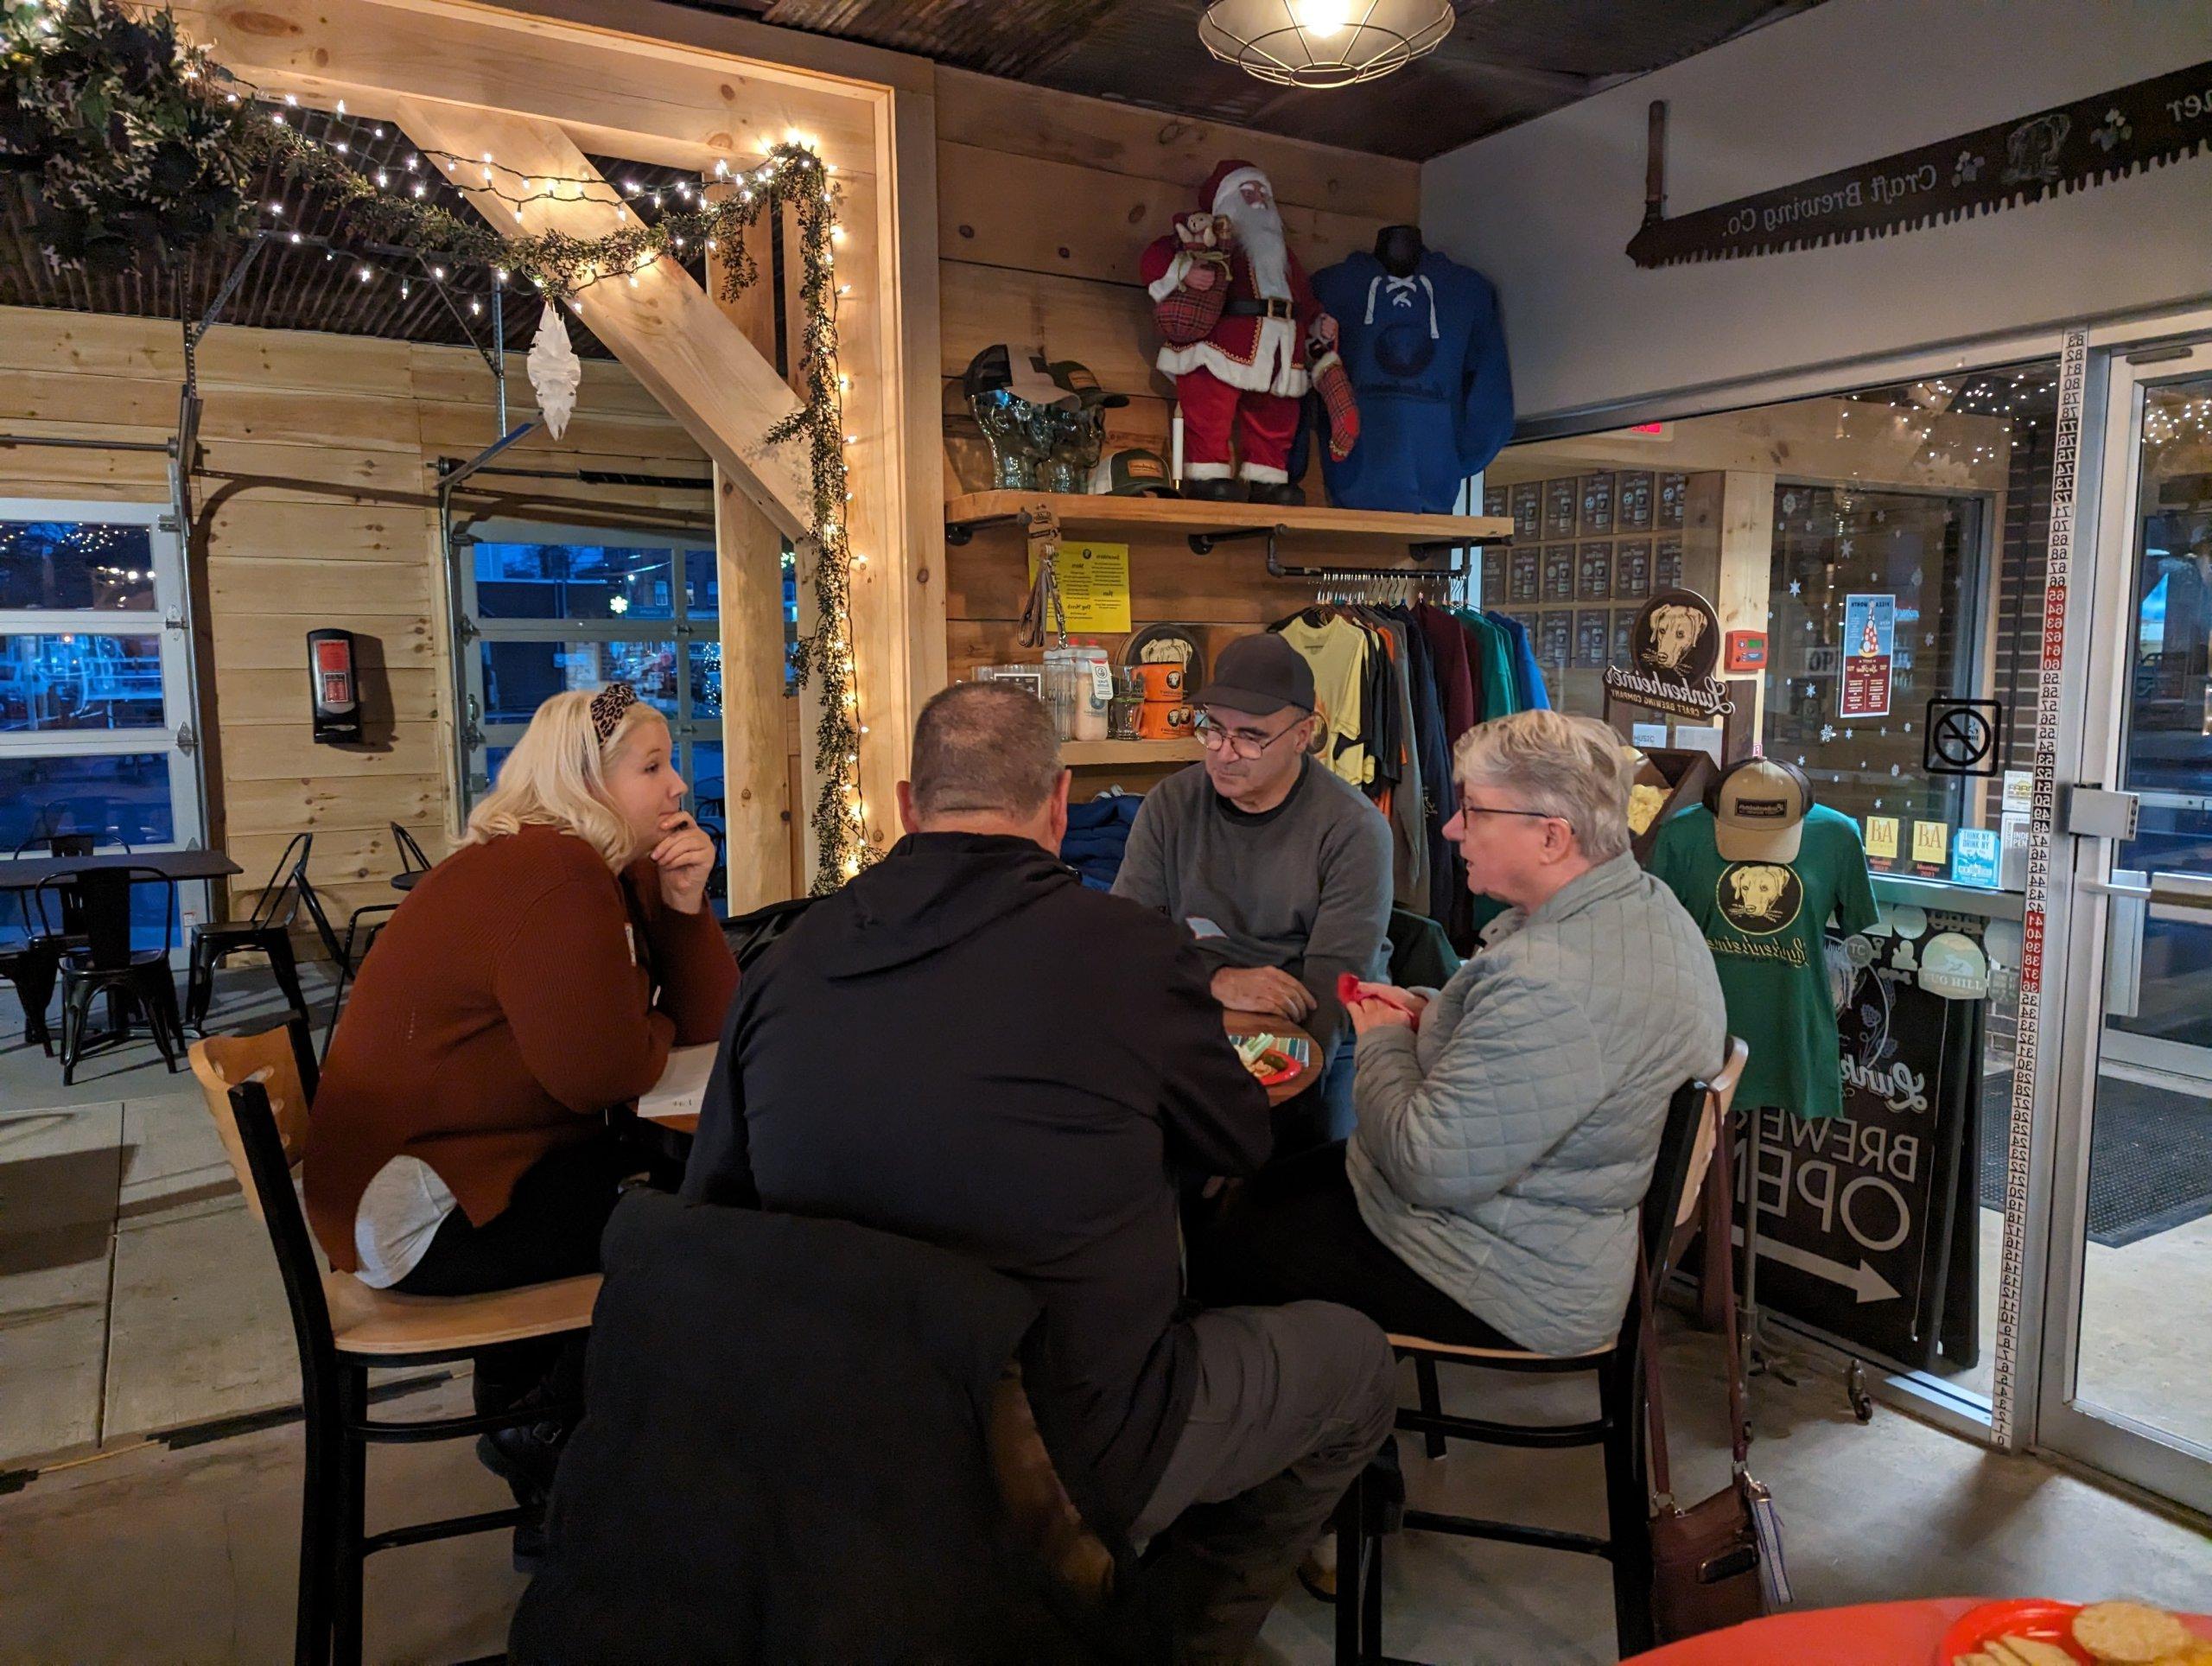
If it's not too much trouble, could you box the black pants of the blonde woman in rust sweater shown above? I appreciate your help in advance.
[394,1133,644,1425]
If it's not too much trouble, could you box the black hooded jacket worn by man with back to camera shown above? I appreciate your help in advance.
[683,834,1269,1533]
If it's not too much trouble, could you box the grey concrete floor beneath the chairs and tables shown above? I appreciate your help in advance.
[0,960,2212,1662]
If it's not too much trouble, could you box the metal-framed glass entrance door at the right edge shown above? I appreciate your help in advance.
[2037,340,2212,1509]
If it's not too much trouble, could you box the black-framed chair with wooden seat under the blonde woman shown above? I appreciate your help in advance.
[190,1020,600,1666]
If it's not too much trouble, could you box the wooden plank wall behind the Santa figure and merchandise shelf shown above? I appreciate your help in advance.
[938,68,1421,797]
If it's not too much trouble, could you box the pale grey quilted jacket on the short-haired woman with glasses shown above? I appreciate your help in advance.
[1344,854,1727,1354]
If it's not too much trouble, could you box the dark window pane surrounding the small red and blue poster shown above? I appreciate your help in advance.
[1767,485,1982,825]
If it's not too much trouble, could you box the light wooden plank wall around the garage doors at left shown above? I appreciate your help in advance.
[0,309,712,942]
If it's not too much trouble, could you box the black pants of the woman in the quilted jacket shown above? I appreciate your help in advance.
[1190,1144,1520,1347]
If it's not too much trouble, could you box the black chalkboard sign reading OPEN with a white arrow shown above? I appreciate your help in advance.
[1737,936,1982,1370]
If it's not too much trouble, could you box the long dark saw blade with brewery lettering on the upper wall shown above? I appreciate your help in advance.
[1628,62,2212,268]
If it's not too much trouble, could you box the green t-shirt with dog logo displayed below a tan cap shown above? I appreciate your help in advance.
[1646,805,1873,1117]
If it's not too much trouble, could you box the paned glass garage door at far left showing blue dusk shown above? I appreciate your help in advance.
[0,500,208,954]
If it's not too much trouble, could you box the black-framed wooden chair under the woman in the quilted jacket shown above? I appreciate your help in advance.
[1336,1038,1750,1666]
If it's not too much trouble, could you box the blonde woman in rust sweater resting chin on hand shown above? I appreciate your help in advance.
[305,684,736,1491]
